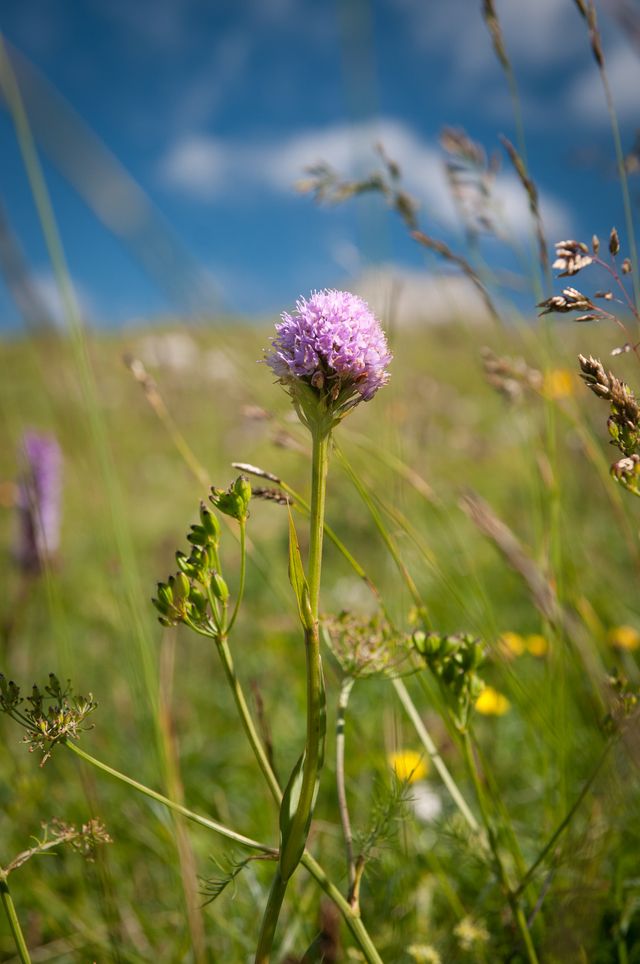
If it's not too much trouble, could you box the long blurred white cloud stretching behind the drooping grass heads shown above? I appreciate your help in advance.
[160,119,571,237]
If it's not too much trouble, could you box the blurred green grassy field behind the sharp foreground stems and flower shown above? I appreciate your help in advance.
[0,312,640,964]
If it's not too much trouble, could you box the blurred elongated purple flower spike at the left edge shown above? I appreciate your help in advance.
[15,432,62,570]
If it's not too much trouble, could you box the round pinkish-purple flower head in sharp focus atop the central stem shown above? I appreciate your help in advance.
[266,290,392,417]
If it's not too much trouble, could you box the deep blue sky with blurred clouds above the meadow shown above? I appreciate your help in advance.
[0,0,640,327]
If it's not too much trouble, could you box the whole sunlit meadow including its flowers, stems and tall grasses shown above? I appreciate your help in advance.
[0,0,640,964]
